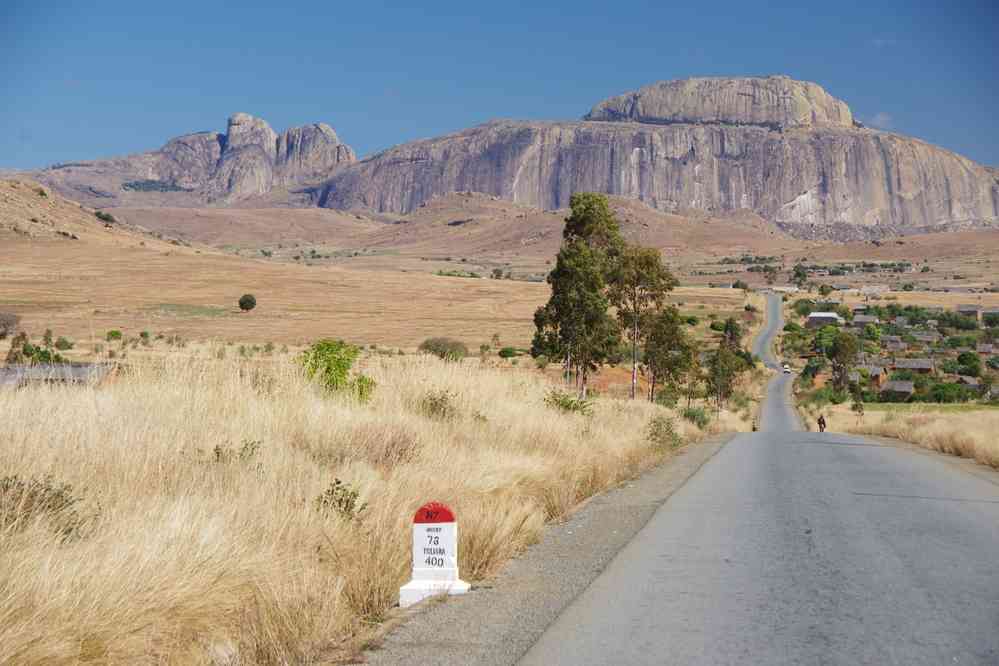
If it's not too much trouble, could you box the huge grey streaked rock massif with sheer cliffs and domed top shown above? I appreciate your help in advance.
[315,77,999,240]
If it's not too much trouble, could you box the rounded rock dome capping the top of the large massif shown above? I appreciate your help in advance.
[584,76,853,129]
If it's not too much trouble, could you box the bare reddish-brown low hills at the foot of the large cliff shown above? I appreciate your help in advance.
[115,192,802,273]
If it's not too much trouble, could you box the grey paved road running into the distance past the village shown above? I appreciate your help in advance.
[521,298,999,666]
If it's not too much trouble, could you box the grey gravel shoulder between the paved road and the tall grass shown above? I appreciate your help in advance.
[364,434,733,665]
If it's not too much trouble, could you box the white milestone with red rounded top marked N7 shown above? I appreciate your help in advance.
[399,502,471,608]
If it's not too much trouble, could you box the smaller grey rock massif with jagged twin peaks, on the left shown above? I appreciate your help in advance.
[33,113,357,206]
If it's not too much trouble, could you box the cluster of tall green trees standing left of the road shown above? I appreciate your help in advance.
[531,192,753,405]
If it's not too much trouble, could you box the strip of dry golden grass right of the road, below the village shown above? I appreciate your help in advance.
[805,405,999,469]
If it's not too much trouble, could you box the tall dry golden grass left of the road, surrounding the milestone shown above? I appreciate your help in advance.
[0,350,741,664]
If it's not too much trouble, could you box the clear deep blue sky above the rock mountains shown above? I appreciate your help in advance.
[0,0,999,168]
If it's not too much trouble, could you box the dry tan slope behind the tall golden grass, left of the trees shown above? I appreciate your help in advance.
[0,181,548,347]
